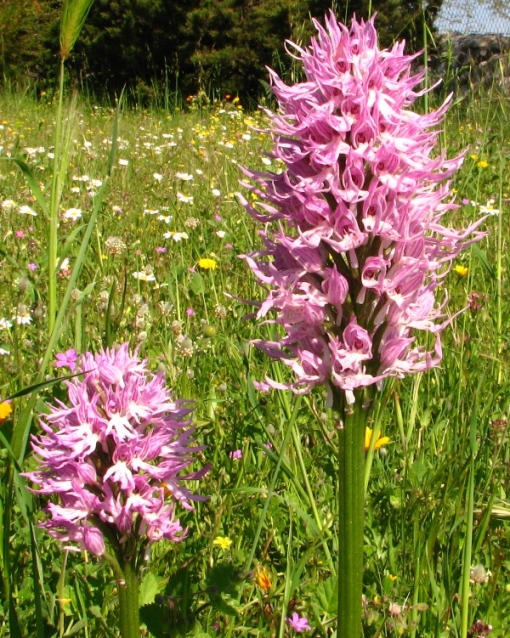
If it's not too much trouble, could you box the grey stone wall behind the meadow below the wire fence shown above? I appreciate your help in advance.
[429,33,510,95]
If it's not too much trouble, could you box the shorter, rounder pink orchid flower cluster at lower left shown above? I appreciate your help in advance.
[25,344,208,556]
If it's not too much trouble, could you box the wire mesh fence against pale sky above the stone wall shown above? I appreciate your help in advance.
[435,0,510,36]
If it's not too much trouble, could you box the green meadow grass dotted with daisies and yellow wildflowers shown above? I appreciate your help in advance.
[0,86,510,638]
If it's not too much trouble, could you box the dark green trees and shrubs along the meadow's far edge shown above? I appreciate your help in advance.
[0,0,442,102]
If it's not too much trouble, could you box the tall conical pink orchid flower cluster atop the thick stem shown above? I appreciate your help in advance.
[239,12,484,404]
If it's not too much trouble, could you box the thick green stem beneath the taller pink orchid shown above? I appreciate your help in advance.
[337,392,368,638]
